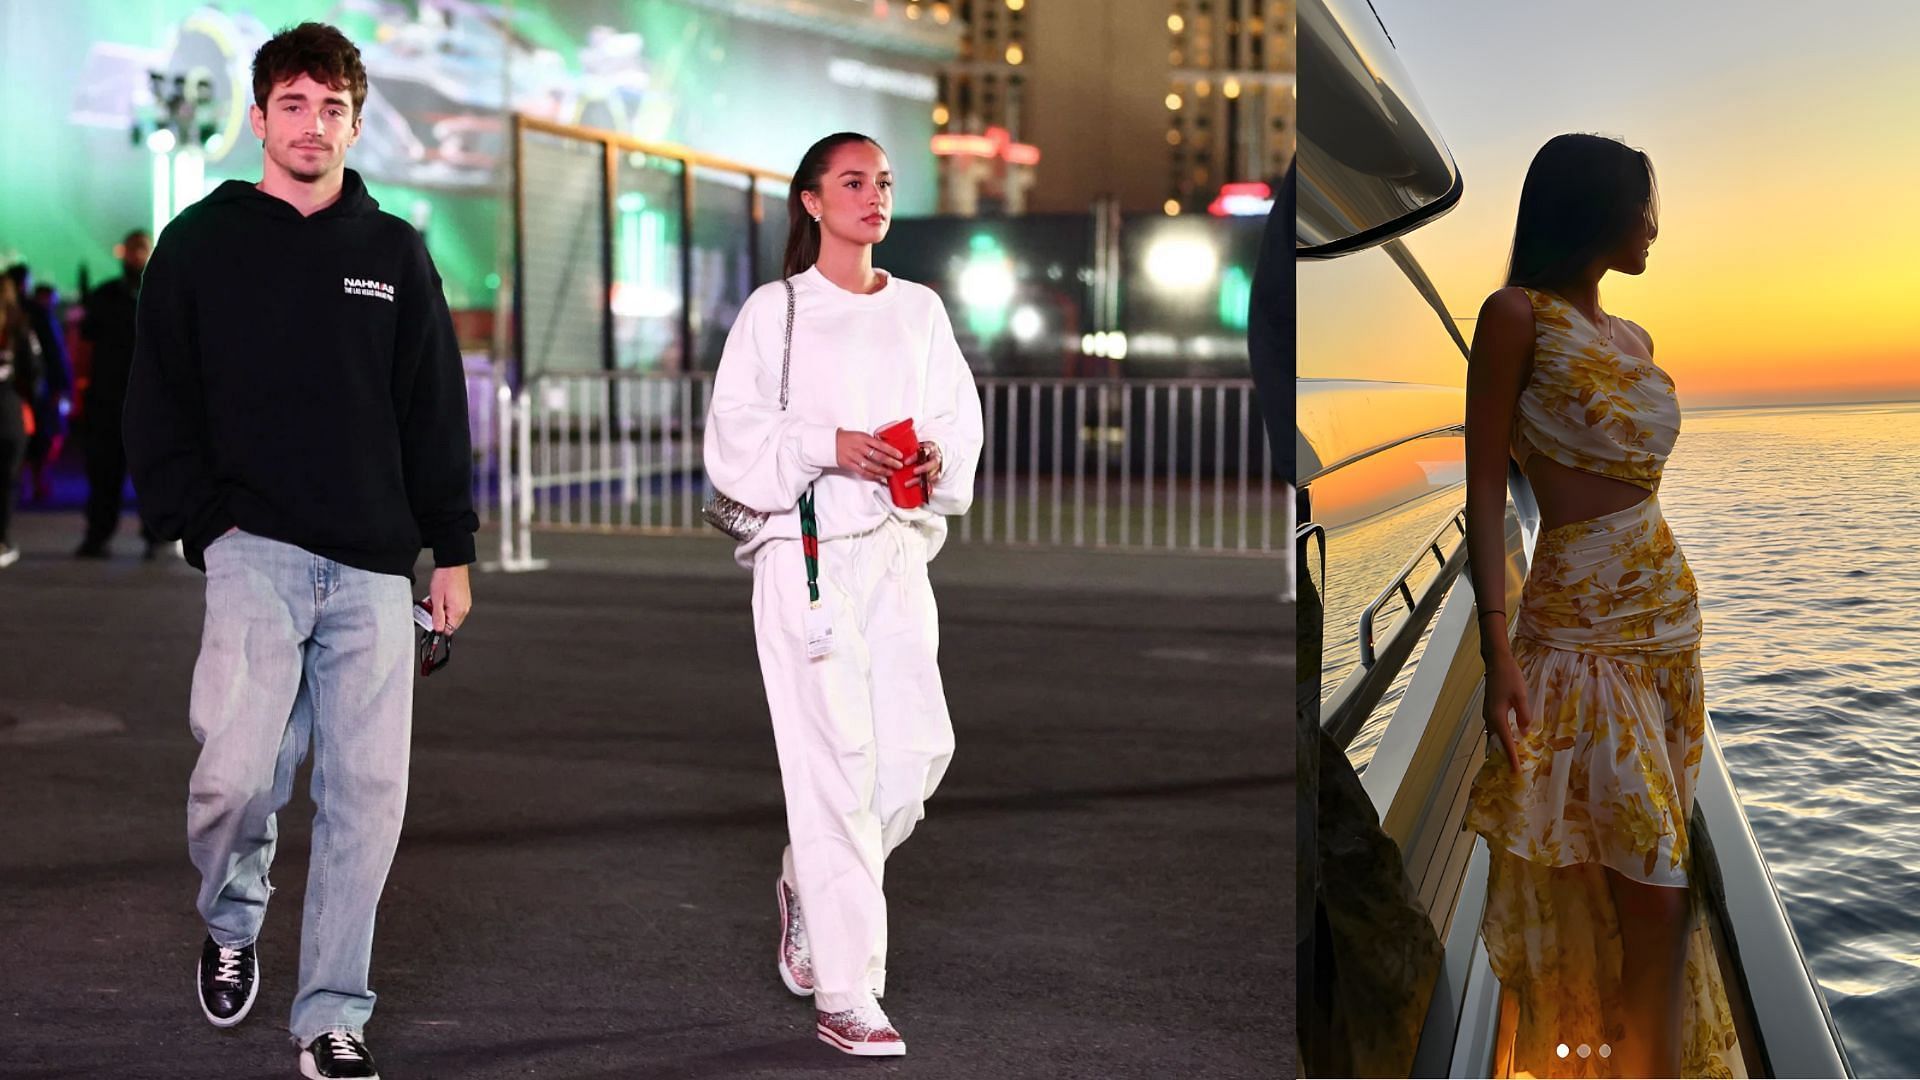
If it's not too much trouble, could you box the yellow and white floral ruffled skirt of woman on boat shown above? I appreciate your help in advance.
[1467,496,1738,1076]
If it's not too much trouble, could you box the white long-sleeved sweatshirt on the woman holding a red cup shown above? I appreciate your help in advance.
[705,267,981,567]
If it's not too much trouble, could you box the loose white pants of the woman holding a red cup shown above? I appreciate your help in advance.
[753,521,954,1013]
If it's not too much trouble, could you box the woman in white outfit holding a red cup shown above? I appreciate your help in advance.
[705,133,981,1055]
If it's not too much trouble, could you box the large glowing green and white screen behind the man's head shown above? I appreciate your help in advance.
[0,0,941,307]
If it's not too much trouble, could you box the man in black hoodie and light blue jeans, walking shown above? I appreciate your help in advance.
[125,23,478,1078]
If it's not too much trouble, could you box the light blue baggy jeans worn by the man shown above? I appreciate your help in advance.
[186,532,415,1045]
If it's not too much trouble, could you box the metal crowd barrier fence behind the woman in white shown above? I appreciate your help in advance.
[488,373,1290,567]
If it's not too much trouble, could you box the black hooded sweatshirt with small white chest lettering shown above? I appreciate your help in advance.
[125,169,478,577]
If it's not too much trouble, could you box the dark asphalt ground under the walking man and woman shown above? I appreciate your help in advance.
[0,511,1294,1080]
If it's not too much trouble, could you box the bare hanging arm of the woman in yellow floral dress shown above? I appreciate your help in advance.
[1467,288,1534,771]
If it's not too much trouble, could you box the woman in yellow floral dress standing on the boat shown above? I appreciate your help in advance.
[1467,135,1736,1076]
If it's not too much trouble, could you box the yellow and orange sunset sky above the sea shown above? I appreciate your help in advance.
[1302,0,1920,405]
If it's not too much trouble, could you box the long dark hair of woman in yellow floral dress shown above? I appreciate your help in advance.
[1507,135,1661,288]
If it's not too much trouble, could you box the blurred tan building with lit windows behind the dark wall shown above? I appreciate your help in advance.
[925,0,1294,215]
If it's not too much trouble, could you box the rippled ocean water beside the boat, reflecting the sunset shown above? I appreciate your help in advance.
[1661,404,1920,1076]
